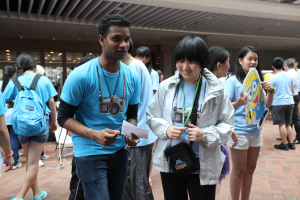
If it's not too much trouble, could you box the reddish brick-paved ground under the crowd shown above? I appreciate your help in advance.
[0,116,300,200]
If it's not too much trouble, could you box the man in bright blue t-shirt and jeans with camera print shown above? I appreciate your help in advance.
[58,14,140,200]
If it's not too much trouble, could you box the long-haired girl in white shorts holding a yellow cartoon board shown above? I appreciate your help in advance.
[224,46,276,200]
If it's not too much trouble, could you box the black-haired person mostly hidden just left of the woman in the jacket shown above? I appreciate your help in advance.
[135,46,159,95]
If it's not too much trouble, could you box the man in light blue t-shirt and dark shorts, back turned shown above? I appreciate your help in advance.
[269,57,295,150]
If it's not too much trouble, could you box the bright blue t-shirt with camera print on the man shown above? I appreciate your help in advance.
[61,57,141,157]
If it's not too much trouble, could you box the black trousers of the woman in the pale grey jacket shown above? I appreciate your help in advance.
[160,172,216,200]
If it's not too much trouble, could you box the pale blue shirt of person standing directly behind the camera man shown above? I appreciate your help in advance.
[129,59,157,146]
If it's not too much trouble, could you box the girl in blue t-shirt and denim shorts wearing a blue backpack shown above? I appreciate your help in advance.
[3,53,57,200]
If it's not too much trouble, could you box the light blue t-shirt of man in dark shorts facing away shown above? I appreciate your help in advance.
[269,72,294,106]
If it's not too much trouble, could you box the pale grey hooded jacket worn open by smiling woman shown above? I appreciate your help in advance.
[147,69,234,185]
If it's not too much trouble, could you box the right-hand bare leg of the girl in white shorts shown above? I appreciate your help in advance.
[241,147,260,200]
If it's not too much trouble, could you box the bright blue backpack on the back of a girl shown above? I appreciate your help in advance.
[11,74,46,136]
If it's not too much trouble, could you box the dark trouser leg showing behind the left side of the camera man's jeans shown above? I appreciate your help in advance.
[69,156,84,200]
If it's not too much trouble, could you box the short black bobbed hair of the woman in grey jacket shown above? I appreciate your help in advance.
[174,35,209,69]
